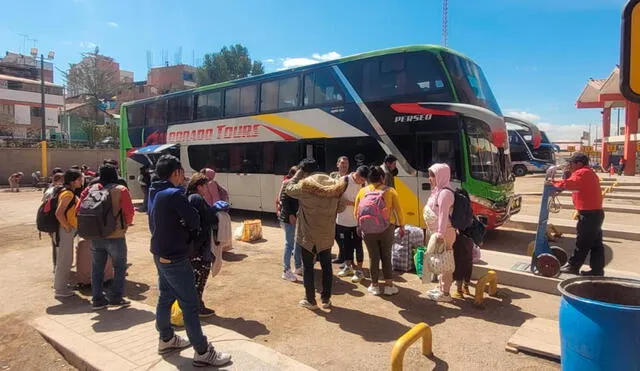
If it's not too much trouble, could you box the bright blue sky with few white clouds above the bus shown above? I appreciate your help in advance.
[0,0,625,140]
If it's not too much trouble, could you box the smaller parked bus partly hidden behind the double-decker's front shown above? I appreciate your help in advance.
[505,116,556,176]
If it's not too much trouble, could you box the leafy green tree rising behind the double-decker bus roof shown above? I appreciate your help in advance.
[197,44,264,86]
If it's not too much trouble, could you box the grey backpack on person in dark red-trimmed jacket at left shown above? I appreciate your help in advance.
[78,184,119,240]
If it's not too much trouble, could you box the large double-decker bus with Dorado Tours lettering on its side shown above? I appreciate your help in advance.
[120,45,520,228]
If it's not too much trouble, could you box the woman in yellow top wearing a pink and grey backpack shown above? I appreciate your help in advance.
[353,166,404,296]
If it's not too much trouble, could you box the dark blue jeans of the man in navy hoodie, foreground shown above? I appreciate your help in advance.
[153,255,208,354]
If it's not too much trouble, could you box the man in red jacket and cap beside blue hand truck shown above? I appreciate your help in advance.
[553,152,604,276]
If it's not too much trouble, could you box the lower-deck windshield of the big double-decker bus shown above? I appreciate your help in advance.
[465,117,511,184]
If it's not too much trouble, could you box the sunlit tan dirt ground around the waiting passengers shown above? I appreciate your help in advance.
[0,192,559,370]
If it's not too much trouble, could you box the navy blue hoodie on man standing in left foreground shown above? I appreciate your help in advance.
[149,180,200,260]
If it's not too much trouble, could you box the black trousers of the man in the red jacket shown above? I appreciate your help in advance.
[569,210,604,273]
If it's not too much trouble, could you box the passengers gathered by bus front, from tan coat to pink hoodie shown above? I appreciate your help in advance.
[277,155,473,309]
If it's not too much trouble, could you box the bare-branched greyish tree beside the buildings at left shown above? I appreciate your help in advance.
[64,47,121,147]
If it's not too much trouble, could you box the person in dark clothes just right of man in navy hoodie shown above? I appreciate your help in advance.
[187,173,218,318]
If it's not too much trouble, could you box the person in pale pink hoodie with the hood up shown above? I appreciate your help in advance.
[423,164,457,302]
